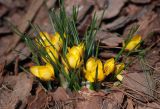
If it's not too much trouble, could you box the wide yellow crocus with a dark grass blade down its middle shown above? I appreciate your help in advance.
[83,57,105,82]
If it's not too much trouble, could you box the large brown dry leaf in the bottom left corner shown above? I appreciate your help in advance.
[0,72,33,109]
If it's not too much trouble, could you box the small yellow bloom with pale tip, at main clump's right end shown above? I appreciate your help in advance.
[115,63,125,81]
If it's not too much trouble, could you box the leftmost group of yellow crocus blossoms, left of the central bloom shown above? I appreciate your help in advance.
[30,32,63,81]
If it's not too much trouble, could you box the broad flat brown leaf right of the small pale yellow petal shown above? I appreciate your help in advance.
[123,73,154,102]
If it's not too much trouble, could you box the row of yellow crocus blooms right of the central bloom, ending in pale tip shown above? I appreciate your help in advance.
[83,57,125,82]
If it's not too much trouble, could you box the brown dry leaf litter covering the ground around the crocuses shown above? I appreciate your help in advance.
[0,0,160,109]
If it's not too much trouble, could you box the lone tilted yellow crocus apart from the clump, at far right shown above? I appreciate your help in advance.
[123,35,142,51]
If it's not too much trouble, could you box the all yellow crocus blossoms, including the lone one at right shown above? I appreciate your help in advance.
[30,32,142,89]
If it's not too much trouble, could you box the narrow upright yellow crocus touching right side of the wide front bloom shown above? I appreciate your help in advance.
[104,58,115,76]
